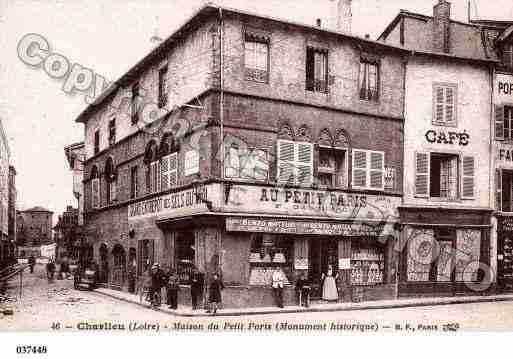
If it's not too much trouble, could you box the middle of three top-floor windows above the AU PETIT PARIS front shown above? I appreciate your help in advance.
[306,47,328,93]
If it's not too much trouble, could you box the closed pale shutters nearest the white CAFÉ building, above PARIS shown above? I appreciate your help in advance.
[353,149,385,190]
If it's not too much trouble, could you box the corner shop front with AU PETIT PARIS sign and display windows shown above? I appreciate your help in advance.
[129,183,401,307]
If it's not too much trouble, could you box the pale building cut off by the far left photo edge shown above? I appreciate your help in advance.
[0,120,16,269]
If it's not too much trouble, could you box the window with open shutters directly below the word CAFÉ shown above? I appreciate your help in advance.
[415,152,475,200]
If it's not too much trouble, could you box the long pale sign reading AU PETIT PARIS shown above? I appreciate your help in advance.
[223,185,401,221]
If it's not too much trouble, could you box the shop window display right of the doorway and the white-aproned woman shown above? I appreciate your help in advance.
[351,240,385,285]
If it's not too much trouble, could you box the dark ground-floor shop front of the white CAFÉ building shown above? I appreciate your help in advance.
[397,206,494,297]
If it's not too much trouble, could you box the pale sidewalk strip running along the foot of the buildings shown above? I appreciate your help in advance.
[94,288,513,317]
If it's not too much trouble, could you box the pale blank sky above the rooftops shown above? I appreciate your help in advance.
[0,0,513,221]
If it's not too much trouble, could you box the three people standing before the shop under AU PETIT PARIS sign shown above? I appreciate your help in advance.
[272,264,338,308]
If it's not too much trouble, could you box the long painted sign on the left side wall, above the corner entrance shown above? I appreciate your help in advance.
[128,185,220,220]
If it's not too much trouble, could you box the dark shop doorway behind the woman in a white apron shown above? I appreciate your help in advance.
[308,237,338,299]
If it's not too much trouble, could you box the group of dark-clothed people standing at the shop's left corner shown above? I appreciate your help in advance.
[141,263,224,314]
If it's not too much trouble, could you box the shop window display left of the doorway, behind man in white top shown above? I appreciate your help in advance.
[249,234,294,285]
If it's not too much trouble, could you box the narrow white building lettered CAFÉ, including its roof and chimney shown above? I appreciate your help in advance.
[379,0,498,296]
